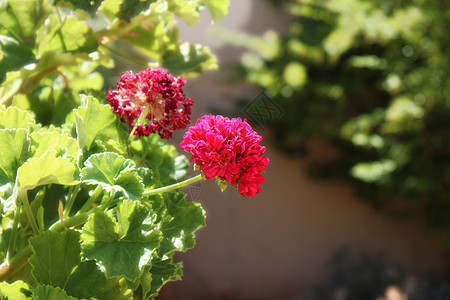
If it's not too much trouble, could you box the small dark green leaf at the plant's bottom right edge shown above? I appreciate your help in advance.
[147,258,183,298]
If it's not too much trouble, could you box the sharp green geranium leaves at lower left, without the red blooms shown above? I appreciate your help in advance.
[0,97,205,299]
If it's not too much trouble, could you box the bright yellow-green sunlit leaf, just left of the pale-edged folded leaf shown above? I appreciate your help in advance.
[17,149,77,190]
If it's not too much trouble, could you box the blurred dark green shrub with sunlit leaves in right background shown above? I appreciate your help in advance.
[237,0,450,234]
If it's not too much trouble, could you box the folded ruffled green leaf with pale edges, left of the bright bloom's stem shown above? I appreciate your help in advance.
[81,152,144,200]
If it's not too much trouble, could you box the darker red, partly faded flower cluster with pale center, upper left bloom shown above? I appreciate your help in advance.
[106,68,193,139]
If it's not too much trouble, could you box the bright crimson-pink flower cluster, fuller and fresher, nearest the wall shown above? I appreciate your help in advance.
[180,115,269,197]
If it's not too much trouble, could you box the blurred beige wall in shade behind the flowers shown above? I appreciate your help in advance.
[160,0,444,299]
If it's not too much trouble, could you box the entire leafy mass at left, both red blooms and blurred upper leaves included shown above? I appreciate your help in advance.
[0,0,268,300]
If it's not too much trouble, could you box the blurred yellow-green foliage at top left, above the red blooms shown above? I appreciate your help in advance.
[0,0,225,125]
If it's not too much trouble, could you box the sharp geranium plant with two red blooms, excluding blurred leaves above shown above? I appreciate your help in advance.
[0,65,269,299]
